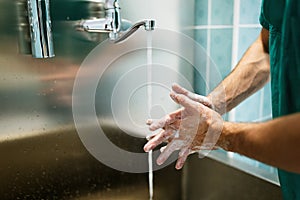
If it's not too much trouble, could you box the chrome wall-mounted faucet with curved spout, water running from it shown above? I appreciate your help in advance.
[76,0,155,43]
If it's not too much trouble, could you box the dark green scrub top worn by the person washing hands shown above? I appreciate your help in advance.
[260,0,300,200]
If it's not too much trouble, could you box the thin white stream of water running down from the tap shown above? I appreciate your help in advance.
[147,31,153,200]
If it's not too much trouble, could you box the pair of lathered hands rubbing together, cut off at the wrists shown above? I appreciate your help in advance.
[144,85,223,169]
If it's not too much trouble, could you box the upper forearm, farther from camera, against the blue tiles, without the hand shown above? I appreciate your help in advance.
[208,29,270,114]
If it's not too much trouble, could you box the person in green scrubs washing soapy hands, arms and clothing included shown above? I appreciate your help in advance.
[144,0,300,199]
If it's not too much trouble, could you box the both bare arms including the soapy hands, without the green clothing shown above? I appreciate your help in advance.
[144,29,300,173]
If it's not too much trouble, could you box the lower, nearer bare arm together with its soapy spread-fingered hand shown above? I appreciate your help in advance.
[144,92,300,173]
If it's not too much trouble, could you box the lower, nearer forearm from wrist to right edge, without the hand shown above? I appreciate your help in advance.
[219,113,300,173]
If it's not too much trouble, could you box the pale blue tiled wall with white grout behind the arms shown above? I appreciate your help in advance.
[191,0,275,184]
